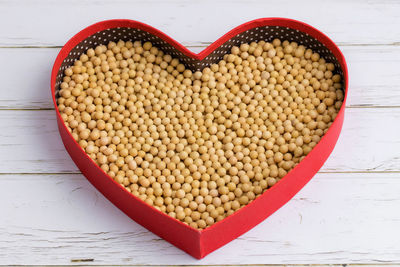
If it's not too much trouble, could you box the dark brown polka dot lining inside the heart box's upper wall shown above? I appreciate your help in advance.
[56,26,343,96]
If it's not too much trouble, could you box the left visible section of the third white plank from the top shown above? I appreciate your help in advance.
[0,110,78,173]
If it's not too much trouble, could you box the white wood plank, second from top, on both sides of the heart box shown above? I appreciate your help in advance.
[0,46,400,109]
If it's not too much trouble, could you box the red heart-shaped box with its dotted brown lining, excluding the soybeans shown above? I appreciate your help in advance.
[51,18,348,259]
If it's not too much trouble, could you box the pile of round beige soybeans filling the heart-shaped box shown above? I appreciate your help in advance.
[57,39,344,229]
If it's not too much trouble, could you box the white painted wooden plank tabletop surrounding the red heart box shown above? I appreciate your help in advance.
[0,0,400,266]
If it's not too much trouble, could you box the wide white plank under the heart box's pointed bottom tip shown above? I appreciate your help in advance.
[0,173,400,265]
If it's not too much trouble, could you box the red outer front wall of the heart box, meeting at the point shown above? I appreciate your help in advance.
[58,110,344,259]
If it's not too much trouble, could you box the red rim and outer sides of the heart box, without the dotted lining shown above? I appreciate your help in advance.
[51,18,348,259]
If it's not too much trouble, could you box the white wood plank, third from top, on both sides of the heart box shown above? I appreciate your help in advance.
[0,108,400,173]
